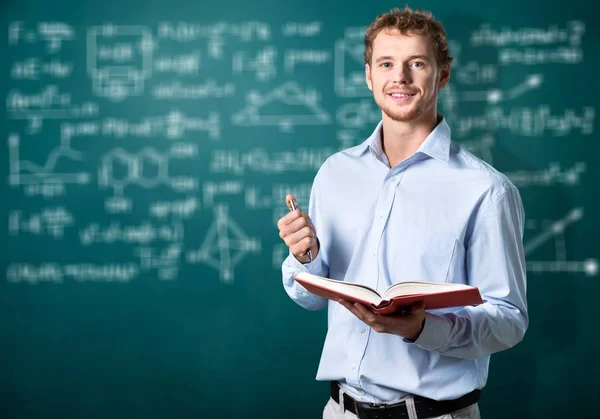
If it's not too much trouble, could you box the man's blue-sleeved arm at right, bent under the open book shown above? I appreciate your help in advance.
[414,185,529,359]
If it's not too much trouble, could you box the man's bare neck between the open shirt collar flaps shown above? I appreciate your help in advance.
[382,114,440,167]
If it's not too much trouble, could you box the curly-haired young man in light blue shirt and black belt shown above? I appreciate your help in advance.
[278,4,528,419]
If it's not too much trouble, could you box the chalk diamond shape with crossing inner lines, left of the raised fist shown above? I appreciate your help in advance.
[186,204,261,283]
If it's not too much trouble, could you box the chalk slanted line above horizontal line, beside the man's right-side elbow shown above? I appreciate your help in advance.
[524,208,598,276]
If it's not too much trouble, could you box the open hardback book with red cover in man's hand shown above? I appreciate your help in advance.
[294,272,483,314]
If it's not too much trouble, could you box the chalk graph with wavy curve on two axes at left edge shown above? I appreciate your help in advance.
[8,134,90,195]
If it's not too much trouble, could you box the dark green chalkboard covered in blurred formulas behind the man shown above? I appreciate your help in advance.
[0,0,600,419]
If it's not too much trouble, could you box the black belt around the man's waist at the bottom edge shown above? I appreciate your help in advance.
[331,381,481,419]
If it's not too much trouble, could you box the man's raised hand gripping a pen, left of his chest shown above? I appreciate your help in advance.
[277,194,319,263]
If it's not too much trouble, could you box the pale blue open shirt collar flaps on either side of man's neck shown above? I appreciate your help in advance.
[355,116,452,163]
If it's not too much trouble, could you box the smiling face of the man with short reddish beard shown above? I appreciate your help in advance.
[365,30,450,122]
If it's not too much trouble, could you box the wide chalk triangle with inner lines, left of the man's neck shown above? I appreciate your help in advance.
[232,81,331,132]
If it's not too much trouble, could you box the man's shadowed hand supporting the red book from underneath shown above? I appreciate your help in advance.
[338,299,425,342]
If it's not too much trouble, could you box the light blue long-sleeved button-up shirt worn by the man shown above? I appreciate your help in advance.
[282,119,529,402]
